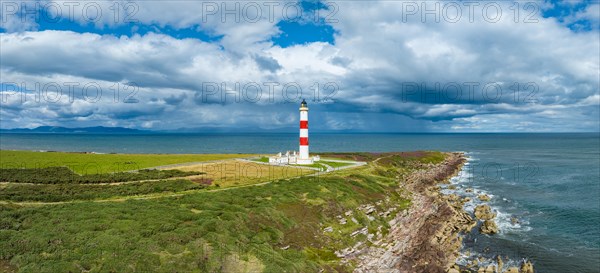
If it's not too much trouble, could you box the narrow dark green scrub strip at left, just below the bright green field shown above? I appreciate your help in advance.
[0,167,203,184]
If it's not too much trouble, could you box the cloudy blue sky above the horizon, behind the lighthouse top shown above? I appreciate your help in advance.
[0,0,600,132]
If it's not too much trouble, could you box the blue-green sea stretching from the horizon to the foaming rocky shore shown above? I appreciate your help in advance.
[0,133,600,273]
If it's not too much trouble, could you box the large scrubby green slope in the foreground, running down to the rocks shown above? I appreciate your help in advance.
[0,150,443,273]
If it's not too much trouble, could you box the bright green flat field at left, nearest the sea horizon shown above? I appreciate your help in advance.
[0,150,252,174]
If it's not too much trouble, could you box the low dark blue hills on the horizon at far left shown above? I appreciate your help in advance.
[0,126,151,134]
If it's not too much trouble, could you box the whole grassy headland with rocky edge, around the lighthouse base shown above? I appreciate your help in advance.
[0,151,532,273]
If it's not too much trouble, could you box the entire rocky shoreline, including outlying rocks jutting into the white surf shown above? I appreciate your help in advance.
[355,153,534,273]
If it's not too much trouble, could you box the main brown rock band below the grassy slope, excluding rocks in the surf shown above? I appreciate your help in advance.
[352,153,468,273]
